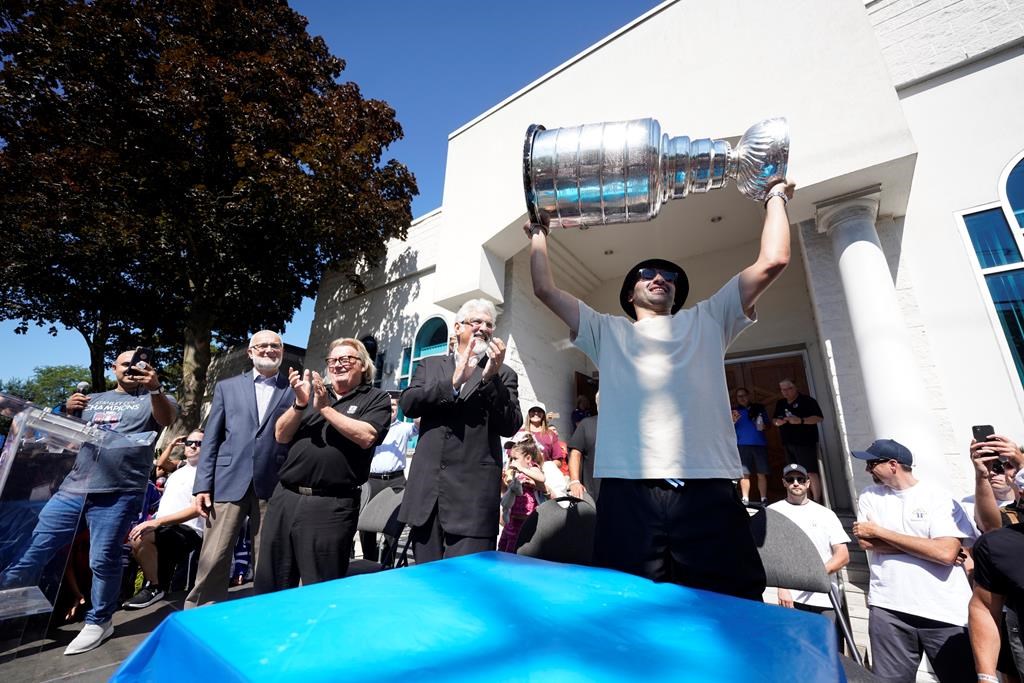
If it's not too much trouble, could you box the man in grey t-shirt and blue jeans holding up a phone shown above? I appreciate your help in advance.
[0,351,178,654]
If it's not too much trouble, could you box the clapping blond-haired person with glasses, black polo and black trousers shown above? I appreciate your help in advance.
[255,338,391,593]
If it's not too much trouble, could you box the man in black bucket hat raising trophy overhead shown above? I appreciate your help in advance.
[524,181,793,601]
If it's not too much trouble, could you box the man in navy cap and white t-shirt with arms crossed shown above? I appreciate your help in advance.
[852,439,975,682]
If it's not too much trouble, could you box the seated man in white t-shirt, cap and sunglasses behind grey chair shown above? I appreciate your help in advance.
[768,463,850,624]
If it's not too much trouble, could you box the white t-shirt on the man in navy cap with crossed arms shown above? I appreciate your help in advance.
[857,481,972,626]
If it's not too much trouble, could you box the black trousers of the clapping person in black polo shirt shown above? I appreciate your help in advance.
[254,483,359,594]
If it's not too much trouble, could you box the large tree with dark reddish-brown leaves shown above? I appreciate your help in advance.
[0,0,416,431]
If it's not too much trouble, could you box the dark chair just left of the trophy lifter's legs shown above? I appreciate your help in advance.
[516,494,597,564]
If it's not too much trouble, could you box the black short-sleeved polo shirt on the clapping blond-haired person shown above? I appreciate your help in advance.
[280,384,391,488]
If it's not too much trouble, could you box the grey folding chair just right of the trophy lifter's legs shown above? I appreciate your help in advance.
[751,508,877,681]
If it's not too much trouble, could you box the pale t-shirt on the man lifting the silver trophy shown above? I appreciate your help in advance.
[574,275,754,479]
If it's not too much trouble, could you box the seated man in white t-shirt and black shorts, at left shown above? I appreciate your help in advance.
[125,430,205,609]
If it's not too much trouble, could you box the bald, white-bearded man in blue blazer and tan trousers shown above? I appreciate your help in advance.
[184,330,295,609]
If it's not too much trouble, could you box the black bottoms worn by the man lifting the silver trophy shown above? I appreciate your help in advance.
[594,478,766,602]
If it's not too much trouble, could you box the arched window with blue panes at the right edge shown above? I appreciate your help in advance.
[963,153,1024,384]
